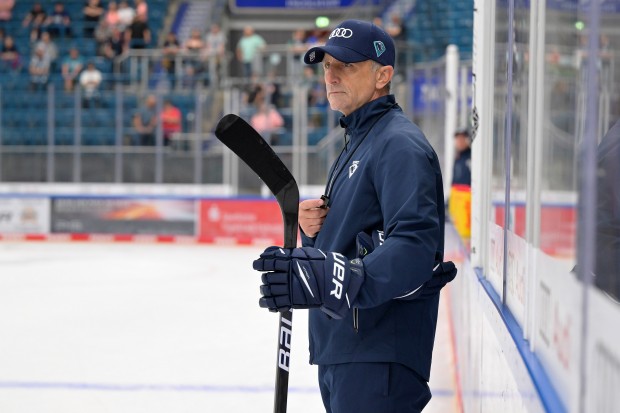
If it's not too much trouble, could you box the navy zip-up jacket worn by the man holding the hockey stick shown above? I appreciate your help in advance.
[302,95,444,380]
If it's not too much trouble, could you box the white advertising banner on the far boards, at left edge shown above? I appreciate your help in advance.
[0,198,50,234]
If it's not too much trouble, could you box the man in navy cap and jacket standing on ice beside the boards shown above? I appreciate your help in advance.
[254,20,456,413]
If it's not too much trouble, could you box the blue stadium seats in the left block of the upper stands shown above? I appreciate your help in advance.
[0,0,168,145]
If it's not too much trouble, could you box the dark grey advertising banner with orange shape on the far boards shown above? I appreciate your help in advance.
[51,197,197,236]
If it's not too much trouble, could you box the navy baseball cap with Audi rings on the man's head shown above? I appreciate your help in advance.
[304,20,396,67]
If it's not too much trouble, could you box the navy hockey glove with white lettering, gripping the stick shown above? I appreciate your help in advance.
[253,247,364,319]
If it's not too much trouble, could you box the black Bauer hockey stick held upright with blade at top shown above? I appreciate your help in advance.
[215,114,299,413]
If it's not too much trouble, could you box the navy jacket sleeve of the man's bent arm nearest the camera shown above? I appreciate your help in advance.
[353,132,443,308]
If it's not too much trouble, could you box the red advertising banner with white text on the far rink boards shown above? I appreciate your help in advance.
[200,199,284,245]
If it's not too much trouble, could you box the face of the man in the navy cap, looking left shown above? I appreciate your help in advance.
[322,54,381,116]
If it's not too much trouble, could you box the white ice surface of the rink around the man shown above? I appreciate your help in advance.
[0,242,459,413]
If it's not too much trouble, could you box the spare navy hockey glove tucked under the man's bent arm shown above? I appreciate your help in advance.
[357,231,457,300]
